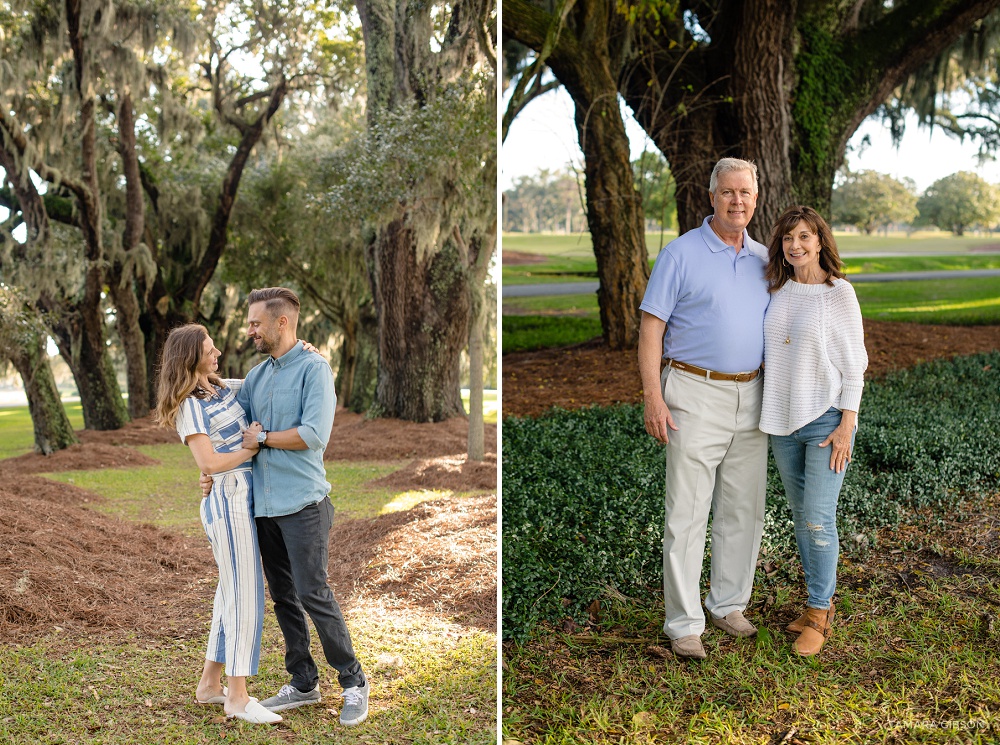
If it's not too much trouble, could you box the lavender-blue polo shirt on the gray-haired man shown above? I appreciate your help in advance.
[639,217,770,373]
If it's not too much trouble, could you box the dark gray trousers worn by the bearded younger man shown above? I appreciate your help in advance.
[256,497,365,691]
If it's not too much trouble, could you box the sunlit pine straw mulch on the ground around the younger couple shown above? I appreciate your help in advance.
[0,411,497,641]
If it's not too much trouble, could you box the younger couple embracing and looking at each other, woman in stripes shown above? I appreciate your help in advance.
[156,287,370,726]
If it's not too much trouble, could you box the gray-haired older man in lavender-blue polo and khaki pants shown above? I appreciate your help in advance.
[639,158,769,659]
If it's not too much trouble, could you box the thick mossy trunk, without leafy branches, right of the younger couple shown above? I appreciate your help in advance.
[357,0,496,422]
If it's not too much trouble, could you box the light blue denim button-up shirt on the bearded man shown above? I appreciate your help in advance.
[237,343,337,517]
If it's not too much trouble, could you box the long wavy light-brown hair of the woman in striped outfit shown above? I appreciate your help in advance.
[153,323,222,427]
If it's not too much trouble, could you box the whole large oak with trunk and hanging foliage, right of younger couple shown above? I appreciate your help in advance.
[354,0,496,429]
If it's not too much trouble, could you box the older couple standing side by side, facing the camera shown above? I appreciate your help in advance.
[639,158,868,659]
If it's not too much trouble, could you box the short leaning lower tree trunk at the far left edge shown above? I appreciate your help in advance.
[7,333,78,455]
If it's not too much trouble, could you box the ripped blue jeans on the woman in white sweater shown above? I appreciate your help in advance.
[771,408,856,608]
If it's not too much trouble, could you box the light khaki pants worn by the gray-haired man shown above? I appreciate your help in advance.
[660,367,767,639]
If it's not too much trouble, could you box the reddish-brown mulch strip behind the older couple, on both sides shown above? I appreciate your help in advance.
[502,320,1000,416]
